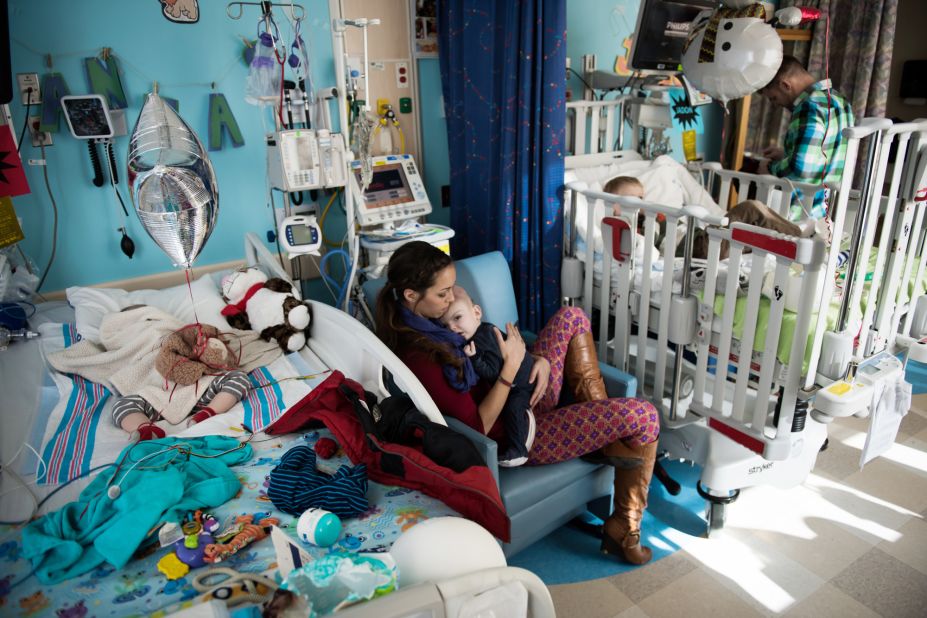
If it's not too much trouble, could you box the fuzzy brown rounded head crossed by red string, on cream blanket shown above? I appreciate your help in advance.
[155,324,238,386]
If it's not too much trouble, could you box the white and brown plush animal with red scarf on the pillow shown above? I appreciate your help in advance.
[222,267,312,352]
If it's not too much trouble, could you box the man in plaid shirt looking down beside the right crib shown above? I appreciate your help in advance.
[759,55,853,220]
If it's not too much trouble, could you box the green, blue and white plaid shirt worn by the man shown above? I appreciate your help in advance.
[769,79,853,220]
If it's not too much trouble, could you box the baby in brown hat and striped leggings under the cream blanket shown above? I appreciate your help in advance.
[113,305,251,441]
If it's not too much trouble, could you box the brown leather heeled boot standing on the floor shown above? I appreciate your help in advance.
[602,442,657,564]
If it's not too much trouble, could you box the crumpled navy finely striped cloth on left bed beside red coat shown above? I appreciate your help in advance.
[267,444,368,517]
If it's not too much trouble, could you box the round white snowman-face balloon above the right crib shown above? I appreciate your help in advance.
[682,9,782,104]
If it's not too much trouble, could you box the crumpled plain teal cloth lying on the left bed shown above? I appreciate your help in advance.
[23,436,253,584]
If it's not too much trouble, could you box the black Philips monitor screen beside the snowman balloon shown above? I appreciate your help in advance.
[631,0,719,72]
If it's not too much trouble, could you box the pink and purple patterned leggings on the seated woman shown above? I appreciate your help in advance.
[528,307,660,464]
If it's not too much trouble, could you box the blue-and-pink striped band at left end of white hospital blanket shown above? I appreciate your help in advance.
[39,324,111,485]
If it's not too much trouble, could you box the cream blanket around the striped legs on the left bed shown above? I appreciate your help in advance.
[48,307,282,424]
